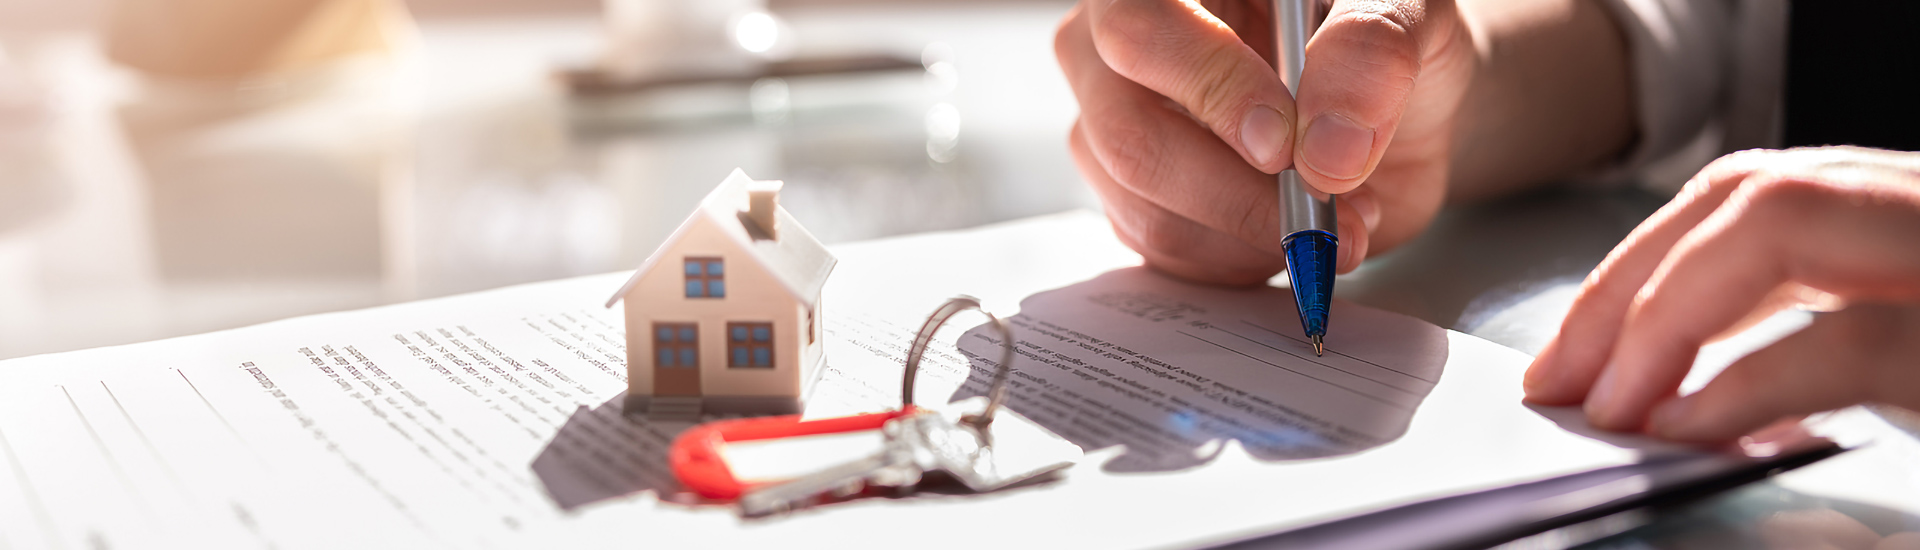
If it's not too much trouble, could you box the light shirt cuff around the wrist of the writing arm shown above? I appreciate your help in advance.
[1596,0,1788,190]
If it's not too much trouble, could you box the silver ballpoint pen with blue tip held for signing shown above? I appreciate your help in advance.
[1273,0,1340,356]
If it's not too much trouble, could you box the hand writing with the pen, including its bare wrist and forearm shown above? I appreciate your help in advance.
[1054,0,1632,285]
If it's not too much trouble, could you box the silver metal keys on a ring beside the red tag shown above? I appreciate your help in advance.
[739,296,1083,517]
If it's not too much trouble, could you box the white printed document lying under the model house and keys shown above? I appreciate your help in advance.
[0,213,1645,548]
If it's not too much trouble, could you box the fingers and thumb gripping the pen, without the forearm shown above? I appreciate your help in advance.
[1054,0,1475,285]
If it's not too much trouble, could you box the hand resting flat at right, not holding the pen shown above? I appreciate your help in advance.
[1526,148,1920,442]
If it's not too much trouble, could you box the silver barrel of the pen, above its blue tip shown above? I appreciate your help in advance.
[1273,0,1340,242]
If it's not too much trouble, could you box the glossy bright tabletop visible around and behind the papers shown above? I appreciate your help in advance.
[0,2,1920,548]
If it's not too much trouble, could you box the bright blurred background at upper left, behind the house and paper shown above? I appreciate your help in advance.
[0,0,1094,360]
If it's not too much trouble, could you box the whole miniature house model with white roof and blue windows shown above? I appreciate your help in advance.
[607,169,835,417]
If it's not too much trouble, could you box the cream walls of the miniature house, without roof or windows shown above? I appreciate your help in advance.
[622,215,818,396]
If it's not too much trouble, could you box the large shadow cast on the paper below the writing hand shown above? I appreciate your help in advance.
[936,267,1448,471]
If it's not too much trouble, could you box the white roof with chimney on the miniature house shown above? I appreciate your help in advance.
[607,167,839,308]
